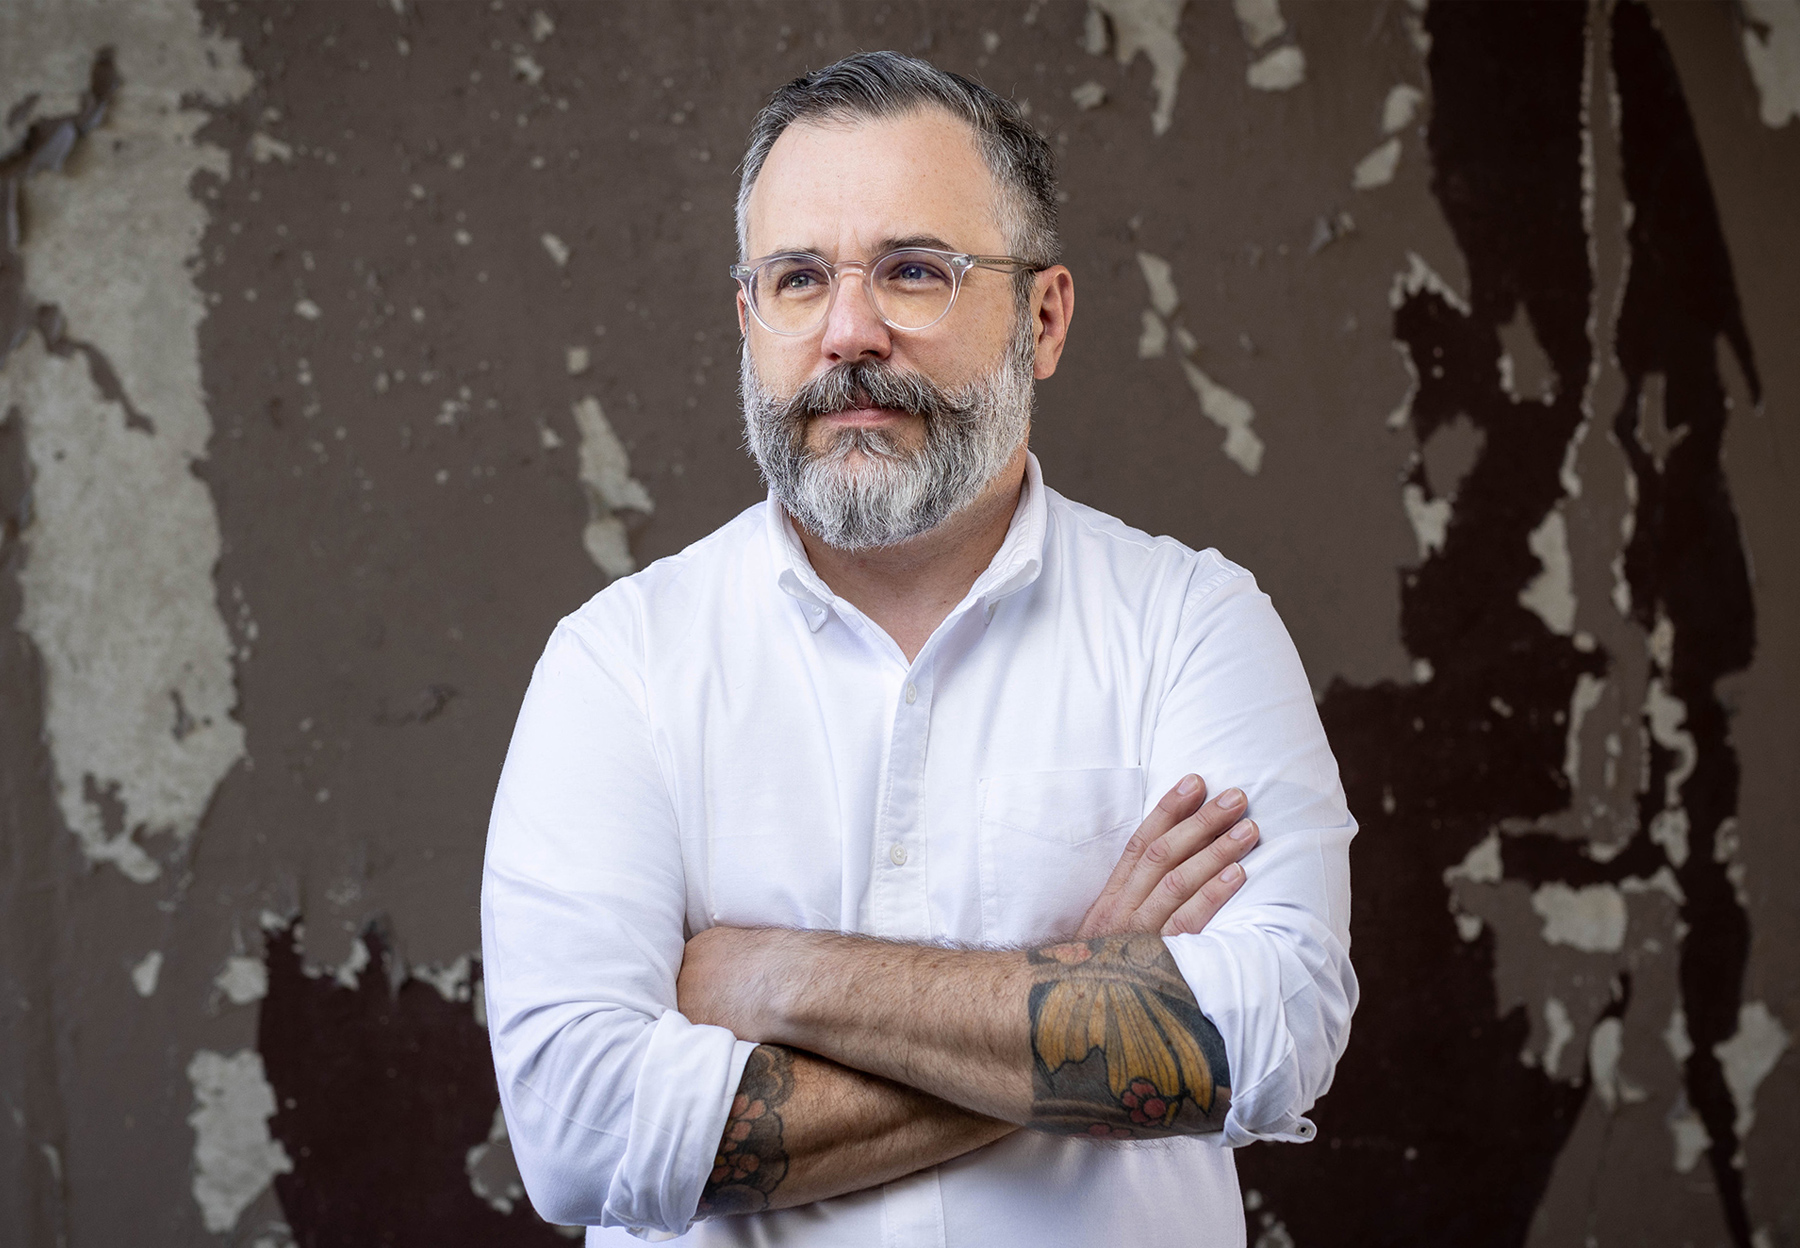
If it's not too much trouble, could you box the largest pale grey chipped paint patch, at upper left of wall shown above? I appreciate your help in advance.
[0,5,252,882]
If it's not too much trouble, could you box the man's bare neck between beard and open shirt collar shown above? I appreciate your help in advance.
[794,447,1026,663]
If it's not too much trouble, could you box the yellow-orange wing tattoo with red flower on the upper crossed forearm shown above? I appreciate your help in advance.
[1028,936,1231,1140]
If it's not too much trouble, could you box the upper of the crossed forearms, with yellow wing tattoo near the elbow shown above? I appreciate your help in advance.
[682,927,1231,1138]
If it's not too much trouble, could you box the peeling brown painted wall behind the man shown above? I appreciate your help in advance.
[0,0,1800,1248]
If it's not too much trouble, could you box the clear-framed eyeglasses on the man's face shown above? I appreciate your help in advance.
[731,247,1042,337]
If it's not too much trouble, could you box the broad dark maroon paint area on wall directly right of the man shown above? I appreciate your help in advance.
[1244,4,1604,1244]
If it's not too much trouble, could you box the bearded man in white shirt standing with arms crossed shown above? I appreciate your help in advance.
[482,52,1357,1246]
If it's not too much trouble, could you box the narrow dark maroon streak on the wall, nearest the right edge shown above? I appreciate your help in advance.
[1613,4,1760,1248]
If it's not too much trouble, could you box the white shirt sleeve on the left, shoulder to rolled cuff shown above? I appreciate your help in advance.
[481,585,754,1234]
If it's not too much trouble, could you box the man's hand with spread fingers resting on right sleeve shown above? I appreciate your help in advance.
[1075,776,1256,940]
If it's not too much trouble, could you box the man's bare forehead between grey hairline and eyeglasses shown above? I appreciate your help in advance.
[747,108,1004,259]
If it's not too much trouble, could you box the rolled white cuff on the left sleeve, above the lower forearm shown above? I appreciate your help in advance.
[601,1010,756,1234]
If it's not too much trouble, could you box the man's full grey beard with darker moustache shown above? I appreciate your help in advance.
[740,317,1035,551]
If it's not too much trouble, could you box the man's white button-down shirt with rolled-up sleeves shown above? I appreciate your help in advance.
[482,457,1357,1248]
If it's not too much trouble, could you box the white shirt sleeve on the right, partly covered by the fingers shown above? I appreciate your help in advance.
[1148,553,1357,1147]
